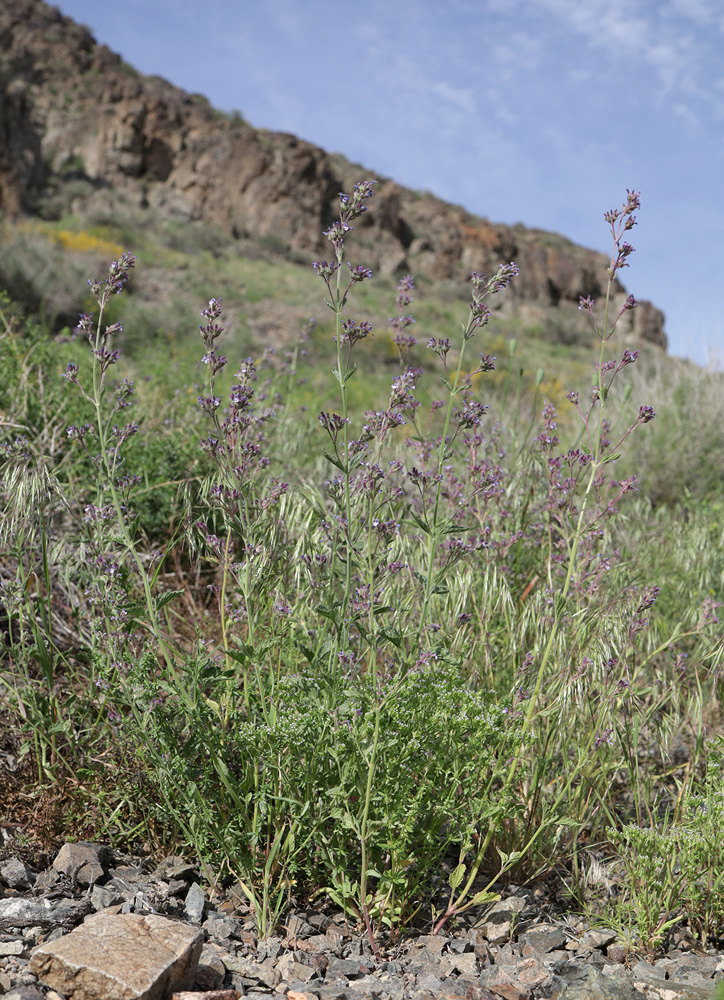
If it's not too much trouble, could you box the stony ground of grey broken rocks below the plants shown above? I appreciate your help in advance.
[0,842,724,1000]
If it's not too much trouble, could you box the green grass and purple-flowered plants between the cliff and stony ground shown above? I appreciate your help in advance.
[0,182,724,951]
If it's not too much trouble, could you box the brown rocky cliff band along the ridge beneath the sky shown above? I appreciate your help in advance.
[0,0,666,348]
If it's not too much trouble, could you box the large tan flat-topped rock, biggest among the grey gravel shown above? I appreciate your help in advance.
[30,911,203,1000]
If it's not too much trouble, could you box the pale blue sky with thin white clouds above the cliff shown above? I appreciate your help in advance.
[56,0,724,366]
